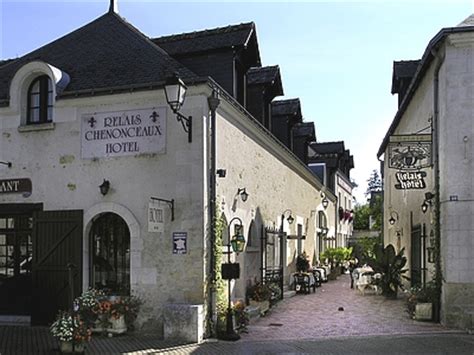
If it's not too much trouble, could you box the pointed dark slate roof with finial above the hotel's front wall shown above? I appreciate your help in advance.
[0,12,198,104]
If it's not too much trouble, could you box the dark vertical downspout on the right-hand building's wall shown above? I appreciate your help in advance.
[431,49,444,322]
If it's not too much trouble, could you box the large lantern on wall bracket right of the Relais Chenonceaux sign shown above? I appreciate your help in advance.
[165,74,193,143]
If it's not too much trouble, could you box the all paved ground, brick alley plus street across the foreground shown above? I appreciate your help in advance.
[0,275,466,355]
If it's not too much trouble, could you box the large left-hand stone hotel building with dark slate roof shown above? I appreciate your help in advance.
[0,6,336,333]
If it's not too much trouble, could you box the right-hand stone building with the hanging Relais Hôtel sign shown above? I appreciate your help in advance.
[378,16,474,329]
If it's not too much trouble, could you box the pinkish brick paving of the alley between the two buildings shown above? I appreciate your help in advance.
[242,275,446,341]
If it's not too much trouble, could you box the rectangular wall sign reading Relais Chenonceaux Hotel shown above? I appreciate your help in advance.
[81,107,166,159]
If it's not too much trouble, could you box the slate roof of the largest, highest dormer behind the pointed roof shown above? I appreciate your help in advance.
[152,22,255,55]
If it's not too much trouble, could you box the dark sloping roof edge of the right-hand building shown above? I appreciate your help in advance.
[377,26,474,158]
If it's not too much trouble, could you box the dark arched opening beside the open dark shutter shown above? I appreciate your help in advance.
[89,212,130,295]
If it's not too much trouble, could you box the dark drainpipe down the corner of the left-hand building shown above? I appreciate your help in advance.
[207,89,220,332]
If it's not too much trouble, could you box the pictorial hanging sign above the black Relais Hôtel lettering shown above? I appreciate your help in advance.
[388,134,431,170]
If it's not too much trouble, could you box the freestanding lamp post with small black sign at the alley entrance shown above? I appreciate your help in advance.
[222,217,245,341]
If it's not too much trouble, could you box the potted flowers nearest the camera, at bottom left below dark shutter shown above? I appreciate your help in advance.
[50,311,92,353]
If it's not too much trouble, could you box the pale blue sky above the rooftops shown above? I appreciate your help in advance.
[0,0,474,203]
